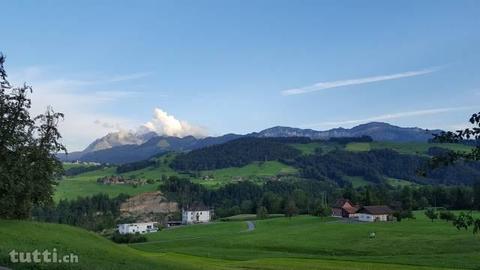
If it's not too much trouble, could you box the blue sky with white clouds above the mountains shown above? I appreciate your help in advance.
[0,0,480,150]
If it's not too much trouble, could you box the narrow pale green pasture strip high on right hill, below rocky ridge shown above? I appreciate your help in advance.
[345,142,472,155]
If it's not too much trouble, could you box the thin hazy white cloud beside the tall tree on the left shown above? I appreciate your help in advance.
[9,67,150,152]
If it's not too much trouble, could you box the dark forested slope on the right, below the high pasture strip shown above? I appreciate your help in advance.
[290,148,480,186]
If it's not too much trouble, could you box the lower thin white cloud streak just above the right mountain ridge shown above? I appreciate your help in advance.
[308,107,475,127]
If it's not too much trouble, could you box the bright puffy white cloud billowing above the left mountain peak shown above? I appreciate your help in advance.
[142,108,206,137]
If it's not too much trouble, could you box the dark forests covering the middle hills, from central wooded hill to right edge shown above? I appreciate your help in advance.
[170,136,480,186]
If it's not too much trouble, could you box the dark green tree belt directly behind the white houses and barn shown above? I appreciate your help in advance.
[160,177,480,217]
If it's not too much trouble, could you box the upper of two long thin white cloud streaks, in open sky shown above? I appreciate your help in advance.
[282,67,440,96]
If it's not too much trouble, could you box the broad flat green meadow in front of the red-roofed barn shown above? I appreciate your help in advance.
[131,213,480,269]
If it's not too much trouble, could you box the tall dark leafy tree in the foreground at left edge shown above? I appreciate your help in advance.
[0,54,66,219]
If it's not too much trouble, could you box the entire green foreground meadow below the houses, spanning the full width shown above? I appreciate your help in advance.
[0,215,472,270]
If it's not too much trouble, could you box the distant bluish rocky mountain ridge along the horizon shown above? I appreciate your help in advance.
[59,122,441,164]
